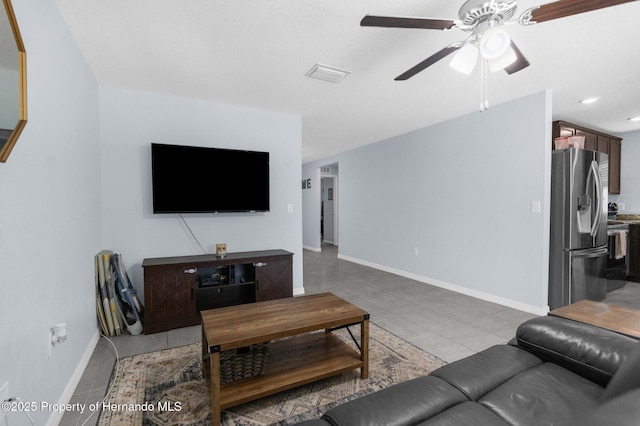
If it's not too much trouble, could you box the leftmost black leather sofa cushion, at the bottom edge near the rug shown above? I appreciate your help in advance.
[322,376,467,426]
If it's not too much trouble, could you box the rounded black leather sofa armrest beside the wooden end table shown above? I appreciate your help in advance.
[516,316,638,386]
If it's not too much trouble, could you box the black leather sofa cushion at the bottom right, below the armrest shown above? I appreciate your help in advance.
[479,363,603,425]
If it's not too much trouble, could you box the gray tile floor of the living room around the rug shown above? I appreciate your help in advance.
[60,246,534,426]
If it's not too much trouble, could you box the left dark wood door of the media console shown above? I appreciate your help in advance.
[144,267,199,333]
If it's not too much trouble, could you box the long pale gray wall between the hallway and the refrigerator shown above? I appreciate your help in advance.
[302,92,551,313]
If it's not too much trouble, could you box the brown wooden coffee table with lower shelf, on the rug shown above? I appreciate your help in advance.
[201,293,369,425]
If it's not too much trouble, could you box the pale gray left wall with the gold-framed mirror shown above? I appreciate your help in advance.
[0,0,101,425]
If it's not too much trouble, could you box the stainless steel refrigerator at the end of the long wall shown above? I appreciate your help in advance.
[549,148,609,309]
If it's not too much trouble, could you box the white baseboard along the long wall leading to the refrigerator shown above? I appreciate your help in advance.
[338,254,549,315]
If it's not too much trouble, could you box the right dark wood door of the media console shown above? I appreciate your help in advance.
[255,259,293,302]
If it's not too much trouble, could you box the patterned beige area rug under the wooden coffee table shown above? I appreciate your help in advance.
[98,324,445,426]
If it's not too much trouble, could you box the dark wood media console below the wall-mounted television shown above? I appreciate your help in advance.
[142,250,293,334]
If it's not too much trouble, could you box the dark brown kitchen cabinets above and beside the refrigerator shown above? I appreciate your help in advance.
[551,121,622,194]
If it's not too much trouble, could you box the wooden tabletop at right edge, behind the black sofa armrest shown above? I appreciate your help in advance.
[549,300,640,339]
